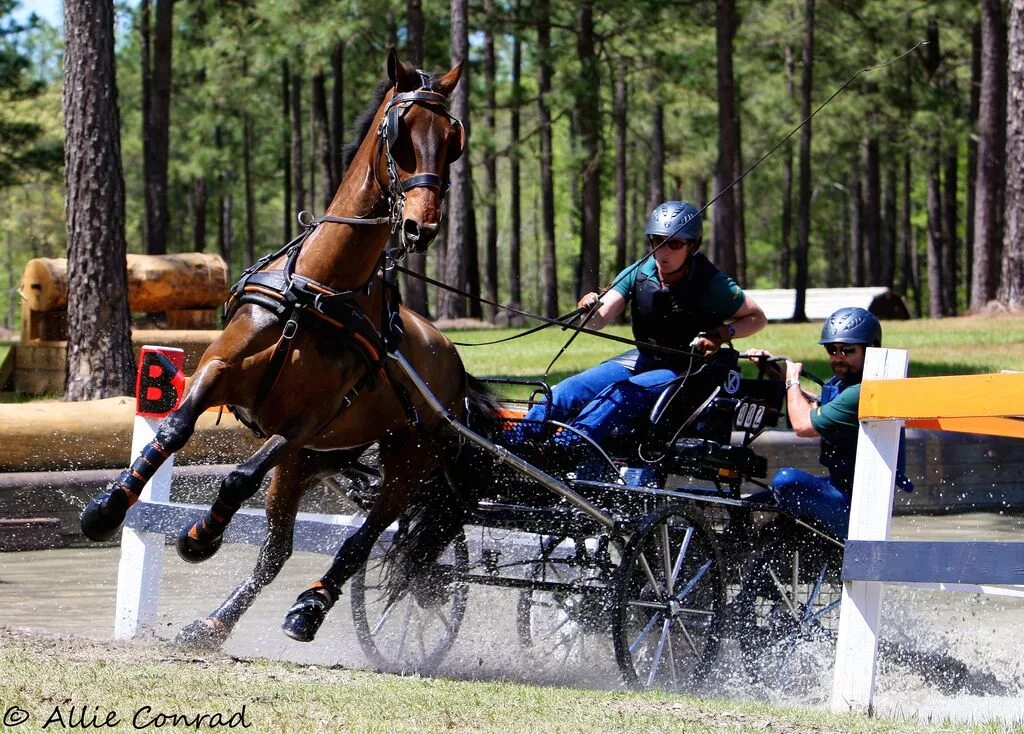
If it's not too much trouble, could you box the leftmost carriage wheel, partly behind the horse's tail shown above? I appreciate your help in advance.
[350,530,469,673]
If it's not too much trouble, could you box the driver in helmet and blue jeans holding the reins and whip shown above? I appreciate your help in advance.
[525,201,767,450]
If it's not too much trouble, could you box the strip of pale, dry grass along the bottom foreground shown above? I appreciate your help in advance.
[0,629,1020,734]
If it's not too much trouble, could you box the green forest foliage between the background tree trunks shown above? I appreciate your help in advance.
[0,0,995,325]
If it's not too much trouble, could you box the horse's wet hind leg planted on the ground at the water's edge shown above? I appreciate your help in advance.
[177,449,361,648]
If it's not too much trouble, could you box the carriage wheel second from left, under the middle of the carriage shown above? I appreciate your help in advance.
[516,535,622,670]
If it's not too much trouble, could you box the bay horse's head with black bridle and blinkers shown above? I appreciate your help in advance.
[377,49,466,252]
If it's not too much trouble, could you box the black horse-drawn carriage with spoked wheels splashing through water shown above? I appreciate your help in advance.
[339,348,842,689]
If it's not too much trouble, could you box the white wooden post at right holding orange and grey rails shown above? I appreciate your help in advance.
[831,348,908,714]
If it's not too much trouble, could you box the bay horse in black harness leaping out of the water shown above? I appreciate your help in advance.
[82,49,487,645]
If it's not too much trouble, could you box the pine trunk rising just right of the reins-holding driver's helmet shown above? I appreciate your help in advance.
[712,0,738,276]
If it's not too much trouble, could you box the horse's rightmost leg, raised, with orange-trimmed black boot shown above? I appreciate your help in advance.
[282,439,438,642]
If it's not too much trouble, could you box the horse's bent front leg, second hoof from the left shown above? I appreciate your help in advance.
[177,434,295,563]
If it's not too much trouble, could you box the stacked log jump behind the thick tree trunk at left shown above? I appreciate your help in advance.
[13,253,229,393]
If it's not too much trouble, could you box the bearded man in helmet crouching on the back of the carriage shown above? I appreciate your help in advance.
[746,307,913,538]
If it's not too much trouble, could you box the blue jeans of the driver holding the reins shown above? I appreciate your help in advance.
[526,354,682,443]
